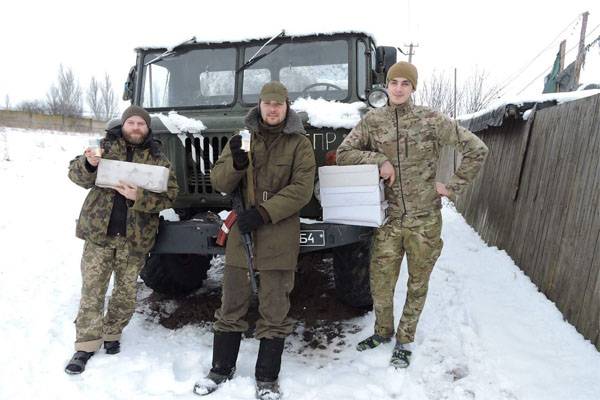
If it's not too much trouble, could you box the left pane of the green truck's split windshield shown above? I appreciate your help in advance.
[141,48,236,108]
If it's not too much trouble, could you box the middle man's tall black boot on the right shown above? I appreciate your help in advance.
[254,338,285,400]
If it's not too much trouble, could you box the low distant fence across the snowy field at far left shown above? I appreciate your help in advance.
[0,110,106,132]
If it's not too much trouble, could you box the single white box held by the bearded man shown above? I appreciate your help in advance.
[96,158,169,193]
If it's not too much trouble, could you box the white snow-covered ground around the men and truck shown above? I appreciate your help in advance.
[0,128,600,400]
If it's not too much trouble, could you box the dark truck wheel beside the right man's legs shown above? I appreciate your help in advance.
[333,240,373,308]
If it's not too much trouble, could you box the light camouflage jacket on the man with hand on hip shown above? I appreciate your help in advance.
[337,102,488,217]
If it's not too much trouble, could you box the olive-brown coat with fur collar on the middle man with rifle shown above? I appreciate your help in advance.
[211,107,315,270]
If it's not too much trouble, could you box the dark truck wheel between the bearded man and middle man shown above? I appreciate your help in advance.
[140,254,211,296]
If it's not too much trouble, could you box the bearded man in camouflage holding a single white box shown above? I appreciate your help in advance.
[65,106,177,374]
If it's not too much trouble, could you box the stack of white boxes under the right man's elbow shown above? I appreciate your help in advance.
[319,165,387,227]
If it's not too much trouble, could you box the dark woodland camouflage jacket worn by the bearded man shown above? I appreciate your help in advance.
[69,126,178,256]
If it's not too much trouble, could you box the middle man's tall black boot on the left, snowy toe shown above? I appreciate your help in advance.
[194,331,242,396]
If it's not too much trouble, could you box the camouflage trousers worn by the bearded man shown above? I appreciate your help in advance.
[75,236,144,352]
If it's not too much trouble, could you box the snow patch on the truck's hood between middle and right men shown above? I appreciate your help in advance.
[291,98,366,129]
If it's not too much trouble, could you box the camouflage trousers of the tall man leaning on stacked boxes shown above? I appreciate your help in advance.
[369,210,443,343]
